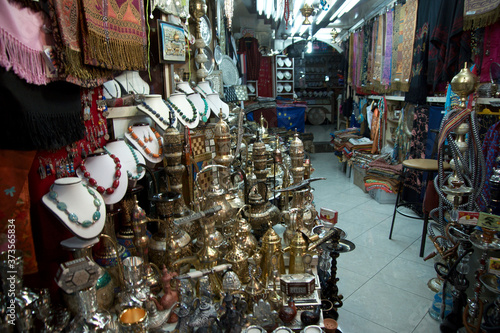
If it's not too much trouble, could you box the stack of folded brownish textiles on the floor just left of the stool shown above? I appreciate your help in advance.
[364,158,402,193]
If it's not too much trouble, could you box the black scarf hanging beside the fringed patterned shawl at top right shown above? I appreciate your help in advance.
[427,0,471,90]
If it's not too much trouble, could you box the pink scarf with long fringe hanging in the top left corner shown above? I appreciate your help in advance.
[0,0,53,85]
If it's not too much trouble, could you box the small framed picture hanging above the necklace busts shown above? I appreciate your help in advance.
[158,20,186,63]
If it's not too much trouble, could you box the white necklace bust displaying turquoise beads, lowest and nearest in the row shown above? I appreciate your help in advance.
[42,176,106,239]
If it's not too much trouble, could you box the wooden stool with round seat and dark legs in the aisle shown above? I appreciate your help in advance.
[389,158,450,257]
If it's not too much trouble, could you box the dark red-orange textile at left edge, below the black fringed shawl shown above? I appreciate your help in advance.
[0,149,38,274]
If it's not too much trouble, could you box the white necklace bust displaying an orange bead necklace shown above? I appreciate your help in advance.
[125,123,163,164]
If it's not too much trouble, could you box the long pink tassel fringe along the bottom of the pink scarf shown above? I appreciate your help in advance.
[0,28,50,85]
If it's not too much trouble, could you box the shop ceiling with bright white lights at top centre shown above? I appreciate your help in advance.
[232,0,395,52]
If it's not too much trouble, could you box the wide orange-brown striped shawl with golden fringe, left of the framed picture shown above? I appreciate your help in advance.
[80,0,147,70]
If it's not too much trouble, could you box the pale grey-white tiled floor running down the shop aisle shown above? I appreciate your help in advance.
[311,152,439,333]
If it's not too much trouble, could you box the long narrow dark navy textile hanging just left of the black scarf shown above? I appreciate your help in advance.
[405,0,444,105]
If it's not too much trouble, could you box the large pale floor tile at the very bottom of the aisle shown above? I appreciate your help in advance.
[344,279,430,333]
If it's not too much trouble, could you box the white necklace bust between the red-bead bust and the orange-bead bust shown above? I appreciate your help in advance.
[104,139,146,189]
